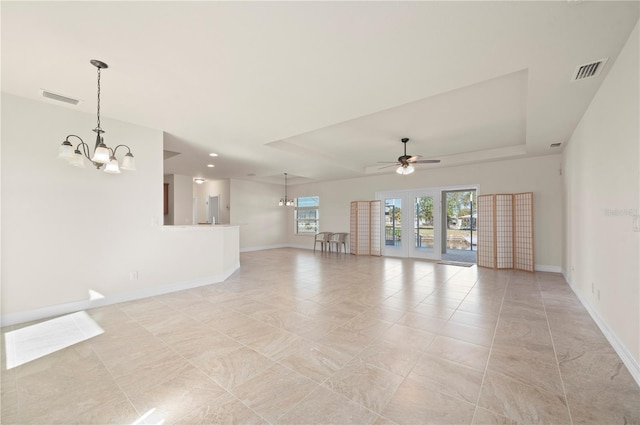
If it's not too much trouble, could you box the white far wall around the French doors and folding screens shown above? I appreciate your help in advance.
[287,155,562,271]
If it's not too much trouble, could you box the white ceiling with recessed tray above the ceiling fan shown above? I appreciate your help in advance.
[1,1,640,184]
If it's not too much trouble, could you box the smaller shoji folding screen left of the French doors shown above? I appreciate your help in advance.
[349,201,382,256]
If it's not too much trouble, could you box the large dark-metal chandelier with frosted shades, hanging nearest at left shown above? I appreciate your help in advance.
[58,59,136,174]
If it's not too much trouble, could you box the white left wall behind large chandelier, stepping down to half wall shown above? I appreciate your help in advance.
[1,93,239,324]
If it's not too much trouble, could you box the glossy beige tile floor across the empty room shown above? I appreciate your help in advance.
[1,249,640,424]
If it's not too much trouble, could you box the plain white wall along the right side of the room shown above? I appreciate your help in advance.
[564,25,640,364]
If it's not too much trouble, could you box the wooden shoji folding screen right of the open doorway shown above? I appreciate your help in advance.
[477,192,535,272]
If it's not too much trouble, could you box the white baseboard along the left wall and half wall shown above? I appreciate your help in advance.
[0,261,240,326]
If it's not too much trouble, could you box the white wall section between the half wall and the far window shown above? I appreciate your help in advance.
[230,179,293,251]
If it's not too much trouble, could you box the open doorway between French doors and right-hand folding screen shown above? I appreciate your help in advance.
[441,189,478,264]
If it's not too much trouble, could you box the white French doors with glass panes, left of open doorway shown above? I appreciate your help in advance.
[376,190,442,260]
